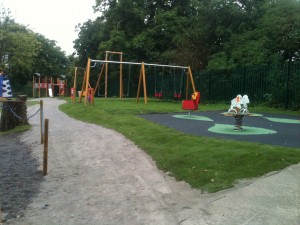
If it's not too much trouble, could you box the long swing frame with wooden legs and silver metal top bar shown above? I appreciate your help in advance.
[80,57,196,104]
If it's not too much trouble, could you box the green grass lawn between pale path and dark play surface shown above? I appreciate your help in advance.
[60,98,300,192]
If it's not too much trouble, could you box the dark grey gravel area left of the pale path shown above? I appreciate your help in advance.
[0,134,44,224]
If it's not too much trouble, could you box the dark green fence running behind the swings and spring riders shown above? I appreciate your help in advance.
[12,62,300,110]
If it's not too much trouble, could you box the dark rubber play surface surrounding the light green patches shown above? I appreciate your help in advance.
[141,111,300,148]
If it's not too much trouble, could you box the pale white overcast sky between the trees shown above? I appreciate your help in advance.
[0,0,96,54]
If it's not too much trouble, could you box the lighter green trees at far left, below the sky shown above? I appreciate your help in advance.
[0,6,69,94]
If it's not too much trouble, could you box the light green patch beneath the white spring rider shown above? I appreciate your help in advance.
[208,124,277,135]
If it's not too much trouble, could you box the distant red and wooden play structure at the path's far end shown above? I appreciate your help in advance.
[32,73,67,98]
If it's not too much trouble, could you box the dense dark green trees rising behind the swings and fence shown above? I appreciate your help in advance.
[75,0,300,69]
